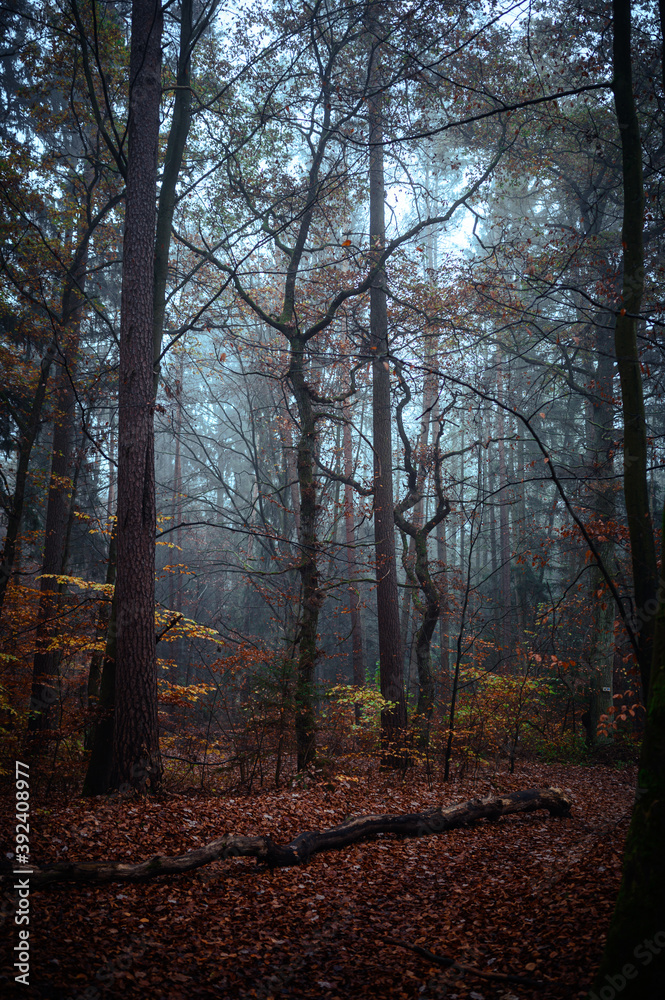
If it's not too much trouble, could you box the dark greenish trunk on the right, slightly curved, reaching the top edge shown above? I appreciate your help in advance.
[613,0,658,705]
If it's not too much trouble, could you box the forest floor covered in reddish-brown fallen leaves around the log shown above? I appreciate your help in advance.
[0,762,635,1000]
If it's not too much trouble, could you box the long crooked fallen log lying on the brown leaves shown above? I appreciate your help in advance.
[0,788,571,890]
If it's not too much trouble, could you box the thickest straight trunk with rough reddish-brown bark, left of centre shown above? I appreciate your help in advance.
[111,0,162,789]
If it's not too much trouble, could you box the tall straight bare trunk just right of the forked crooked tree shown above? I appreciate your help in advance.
[367,2,406,767]
